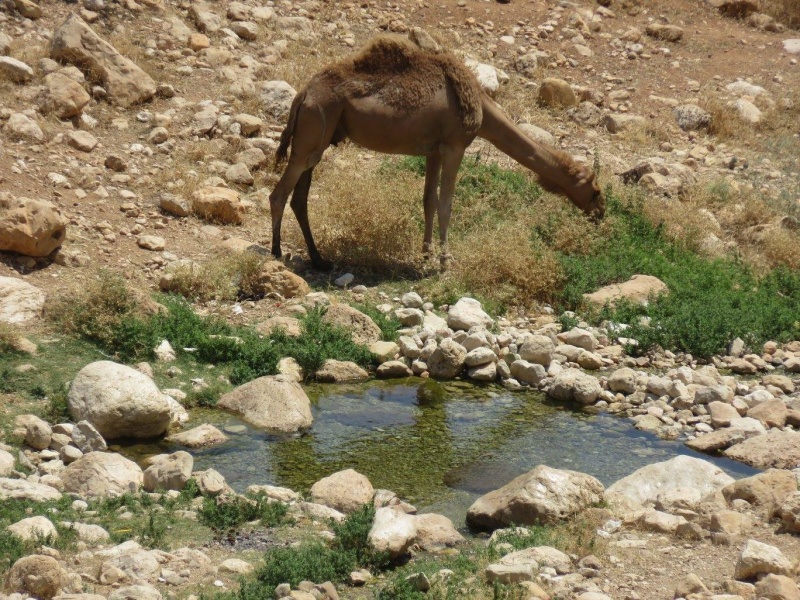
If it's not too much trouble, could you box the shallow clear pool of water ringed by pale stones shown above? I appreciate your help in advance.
[119,380,755,523]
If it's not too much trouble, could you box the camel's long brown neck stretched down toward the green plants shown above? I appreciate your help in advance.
[478,98,584,207]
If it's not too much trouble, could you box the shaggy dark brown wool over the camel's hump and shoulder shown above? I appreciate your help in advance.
[320,35,482,132]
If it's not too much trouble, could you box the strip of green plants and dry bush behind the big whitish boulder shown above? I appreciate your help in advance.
[47,273,373,382]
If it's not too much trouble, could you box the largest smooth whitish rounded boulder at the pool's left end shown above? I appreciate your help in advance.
[67,360,171,440]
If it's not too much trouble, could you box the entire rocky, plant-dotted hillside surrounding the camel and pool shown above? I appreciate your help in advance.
[0,0,800,600]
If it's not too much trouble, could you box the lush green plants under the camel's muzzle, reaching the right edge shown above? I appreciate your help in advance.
[556,196,800,358]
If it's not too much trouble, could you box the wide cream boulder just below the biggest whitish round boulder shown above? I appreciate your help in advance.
[60,452,144,498]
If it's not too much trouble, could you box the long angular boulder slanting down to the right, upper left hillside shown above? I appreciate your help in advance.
[50,13,156,106]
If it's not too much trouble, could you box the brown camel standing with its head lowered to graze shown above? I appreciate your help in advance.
[270,35,605,270]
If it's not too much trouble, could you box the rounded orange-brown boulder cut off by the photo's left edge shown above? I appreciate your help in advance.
[0,194,67,257]
